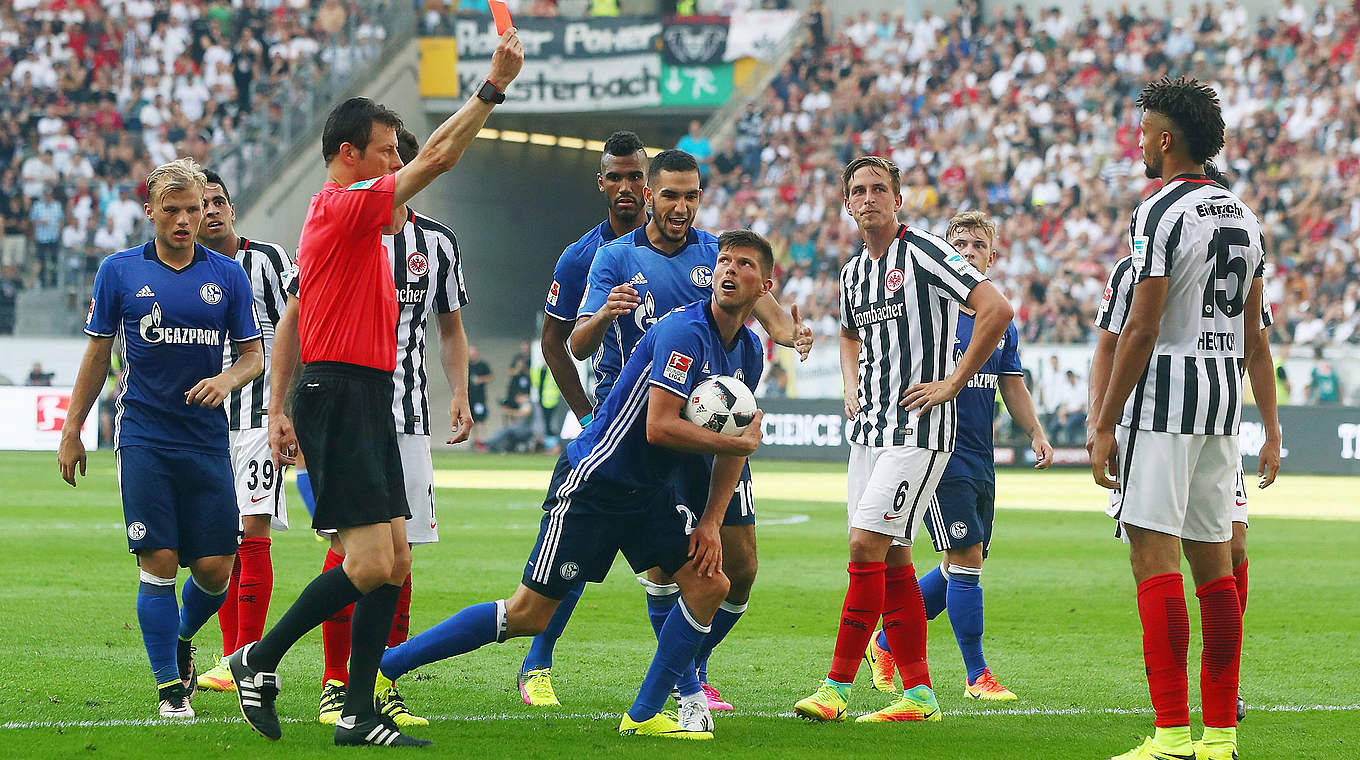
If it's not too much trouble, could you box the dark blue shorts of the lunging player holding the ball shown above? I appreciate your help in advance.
[522,453,694,600]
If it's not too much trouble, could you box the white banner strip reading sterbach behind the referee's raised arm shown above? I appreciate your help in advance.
[458,53,661,112]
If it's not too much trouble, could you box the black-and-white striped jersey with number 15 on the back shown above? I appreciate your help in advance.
[1119,175,1265,435]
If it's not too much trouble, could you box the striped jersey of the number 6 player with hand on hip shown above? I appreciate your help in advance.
[840,226,987,451]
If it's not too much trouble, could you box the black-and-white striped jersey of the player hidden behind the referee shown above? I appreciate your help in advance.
[288,207,468,435]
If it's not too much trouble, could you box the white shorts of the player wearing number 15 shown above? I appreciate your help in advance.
[1106,426,1247,542]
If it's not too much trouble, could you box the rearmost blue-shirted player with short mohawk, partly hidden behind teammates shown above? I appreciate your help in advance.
[515,132,647,706]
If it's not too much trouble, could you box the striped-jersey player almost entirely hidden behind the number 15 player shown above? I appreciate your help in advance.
[1087,163,1281,721]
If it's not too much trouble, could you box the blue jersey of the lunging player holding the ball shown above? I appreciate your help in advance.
[567,299,764,489]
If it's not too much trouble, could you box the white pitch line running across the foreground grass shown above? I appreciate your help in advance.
[0,704,1360,730]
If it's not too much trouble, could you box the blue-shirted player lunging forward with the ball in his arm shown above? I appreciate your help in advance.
[382,231,774,740]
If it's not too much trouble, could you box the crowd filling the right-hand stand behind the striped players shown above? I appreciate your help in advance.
[681,0,1360,345]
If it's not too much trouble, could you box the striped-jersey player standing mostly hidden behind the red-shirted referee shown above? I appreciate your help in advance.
[269,128,473,726]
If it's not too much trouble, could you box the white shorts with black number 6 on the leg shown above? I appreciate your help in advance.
[846,442,949,547]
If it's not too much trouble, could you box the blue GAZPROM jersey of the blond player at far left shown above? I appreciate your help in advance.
[84,241,260,455]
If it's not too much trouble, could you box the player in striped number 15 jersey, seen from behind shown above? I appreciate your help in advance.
[1091,77,1265,760]
